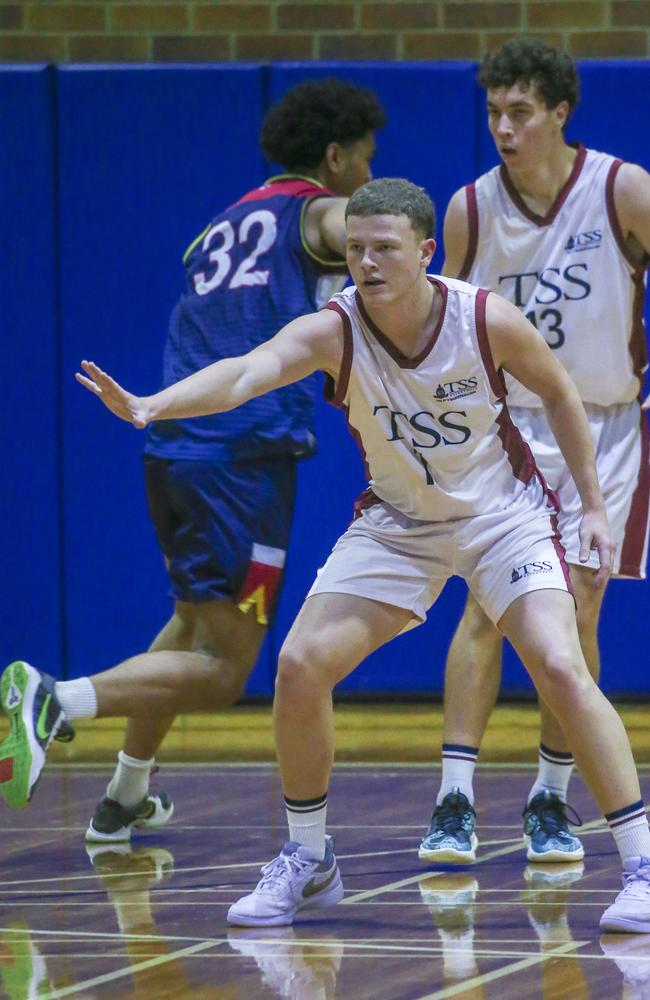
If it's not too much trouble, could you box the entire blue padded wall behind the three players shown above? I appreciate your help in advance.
[0,61,650,693]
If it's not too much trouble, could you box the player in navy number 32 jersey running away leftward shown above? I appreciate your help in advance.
[0,79,385,841]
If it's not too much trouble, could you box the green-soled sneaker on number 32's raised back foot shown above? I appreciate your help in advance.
[0,660,70,809]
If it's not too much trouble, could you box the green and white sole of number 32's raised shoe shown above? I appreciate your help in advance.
[0,660,57,809]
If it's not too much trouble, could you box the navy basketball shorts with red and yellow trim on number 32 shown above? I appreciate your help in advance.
[144,455,296,625]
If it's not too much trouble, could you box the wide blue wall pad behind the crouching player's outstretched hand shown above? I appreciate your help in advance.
[53,65,270,691]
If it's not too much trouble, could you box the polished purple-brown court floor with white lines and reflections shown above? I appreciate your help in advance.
[0,764,650,1000]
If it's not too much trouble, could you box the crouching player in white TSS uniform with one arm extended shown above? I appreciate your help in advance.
[77,179,650,932]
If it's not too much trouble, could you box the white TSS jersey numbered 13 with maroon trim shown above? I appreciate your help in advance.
[461,146,647,407]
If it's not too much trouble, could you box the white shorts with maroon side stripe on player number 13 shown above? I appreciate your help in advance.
[510,402,650,580]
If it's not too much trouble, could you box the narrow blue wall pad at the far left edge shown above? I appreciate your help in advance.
[0,66,62,673]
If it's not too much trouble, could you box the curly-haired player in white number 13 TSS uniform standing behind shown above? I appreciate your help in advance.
[419,39,650,863]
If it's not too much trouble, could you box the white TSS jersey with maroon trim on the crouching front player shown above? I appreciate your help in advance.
[327,276,536,521]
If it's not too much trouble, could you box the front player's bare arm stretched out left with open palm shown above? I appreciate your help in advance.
[75,309,343,428]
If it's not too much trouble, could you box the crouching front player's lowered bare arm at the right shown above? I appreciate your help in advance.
[486,293,614,588]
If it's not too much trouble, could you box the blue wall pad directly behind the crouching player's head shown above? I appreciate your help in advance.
[269,63,478,692]
